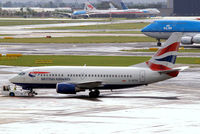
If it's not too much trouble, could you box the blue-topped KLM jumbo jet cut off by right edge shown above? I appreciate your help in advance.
[141,20,200,46]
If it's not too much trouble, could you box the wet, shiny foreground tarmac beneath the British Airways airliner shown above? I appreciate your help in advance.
[0,66,200,134]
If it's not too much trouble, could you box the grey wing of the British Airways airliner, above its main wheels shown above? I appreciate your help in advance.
[70,81,102,88]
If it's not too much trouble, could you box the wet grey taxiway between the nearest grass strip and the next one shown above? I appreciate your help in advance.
[0,42,200,57]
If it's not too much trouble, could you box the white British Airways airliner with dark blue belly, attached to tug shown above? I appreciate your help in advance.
[10,33,186,97]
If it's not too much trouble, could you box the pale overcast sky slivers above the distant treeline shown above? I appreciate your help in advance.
[0,0,167,3]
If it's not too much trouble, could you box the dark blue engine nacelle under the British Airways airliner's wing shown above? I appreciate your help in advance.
[56,83,77,94]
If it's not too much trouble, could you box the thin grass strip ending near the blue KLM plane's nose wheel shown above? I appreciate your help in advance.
[0,36,156,43]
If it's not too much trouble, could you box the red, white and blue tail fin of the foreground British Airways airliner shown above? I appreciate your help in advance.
[146,33,182,71]
